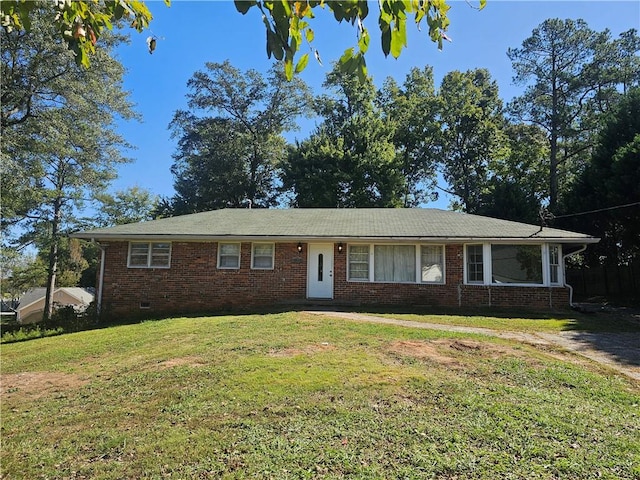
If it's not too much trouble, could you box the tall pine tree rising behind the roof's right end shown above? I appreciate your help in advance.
[507,19,640,210]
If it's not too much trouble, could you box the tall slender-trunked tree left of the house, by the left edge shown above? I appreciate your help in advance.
[0,2,135,316]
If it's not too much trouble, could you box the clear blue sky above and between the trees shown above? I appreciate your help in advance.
[112,0,640,208]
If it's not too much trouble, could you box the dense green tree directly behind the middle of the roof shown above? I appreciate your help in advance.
[282,66,403,208]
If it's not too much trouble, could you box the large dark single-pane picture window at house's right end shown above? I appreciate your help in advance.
[491,245,542,285]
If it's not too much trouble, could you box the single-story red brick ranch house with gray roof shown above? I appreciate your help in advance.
[74,209,598,314]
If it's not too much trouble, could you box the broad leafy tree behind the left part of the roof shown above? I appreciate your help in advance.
[163,61,308,215]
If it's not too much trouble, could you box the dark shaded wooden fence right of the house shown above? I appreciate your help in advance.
[566,262,640,297]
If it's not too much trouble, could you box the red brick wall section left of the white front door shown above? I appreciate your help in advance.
[102,242,307,314]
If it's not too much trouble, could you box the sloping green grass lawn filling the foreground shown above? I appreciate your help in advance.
[0,312,640,479]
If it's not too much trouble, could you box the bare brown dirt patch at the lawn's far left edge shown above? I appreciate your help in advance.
[0,372,89,400]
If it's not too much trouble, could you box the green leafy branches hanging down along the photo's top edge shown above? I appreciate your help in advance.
[0,0,486,76]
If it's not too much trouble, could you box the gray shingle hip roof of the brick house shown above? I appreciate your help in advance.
[73,208,598,243]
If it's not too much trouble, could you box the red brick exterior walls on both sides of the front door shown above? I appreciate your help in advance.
[102,242,569,316]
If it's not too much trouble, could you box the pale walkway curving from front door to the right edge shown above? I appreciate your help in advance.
[307,310,640,382]
